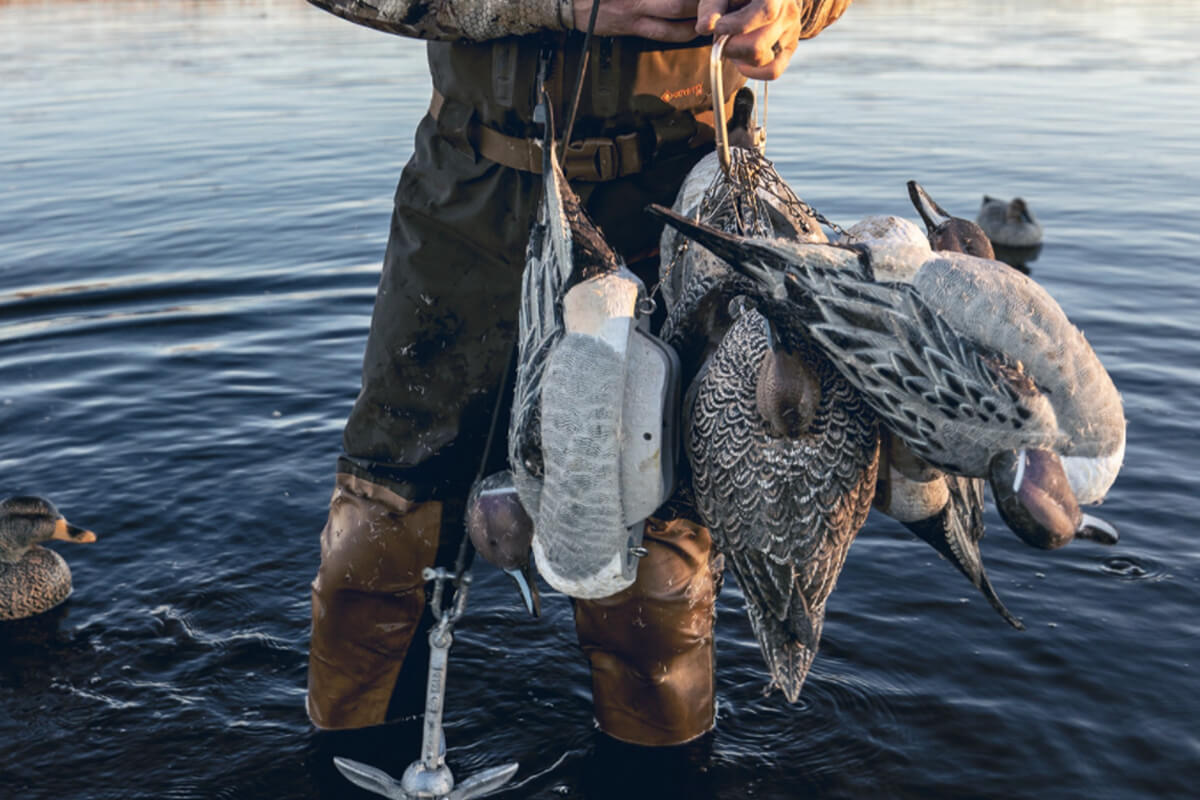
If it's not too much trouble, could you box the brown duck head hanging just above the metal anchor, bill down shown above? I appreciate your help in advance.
[466,470,541,616]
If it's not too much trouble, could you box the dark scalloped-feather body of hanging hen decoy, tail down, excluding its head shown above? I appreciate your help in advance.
[686,309,878,702]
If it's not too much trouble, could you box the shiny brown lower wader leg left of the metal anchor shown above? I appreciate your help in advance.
[307,473,442,730]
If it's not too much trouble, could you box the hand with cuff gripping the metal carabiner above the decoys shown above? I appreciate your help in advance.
[696,0,851,80]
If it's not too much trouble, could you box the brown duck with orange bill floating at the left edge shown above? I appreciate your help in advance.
[0,497,96,620]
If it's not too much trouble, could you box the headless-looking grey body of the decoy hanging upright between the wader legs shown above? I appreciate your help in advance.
[509,95,678,599]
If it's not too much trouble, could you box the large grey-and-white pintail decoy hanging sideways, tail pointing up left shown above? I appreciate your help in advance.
[653,196,1124,548]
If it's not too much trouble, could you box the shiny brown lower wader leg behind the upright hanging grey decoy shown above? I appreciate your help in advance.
[575,519,721,747]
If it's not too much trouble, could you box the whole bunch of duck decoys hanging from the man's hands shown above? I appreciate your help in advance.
[468,48,1124,700]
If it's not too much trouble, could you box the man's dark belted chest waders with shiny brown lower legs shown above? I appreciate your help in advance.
[307,34,744,745]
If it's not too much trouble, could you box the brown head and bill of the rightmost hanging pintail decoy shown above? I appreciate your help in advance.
[989,450,1117,549]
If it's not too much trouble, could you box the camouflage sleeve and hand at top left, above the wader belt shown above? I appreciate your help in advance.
[308,0,700,42]
